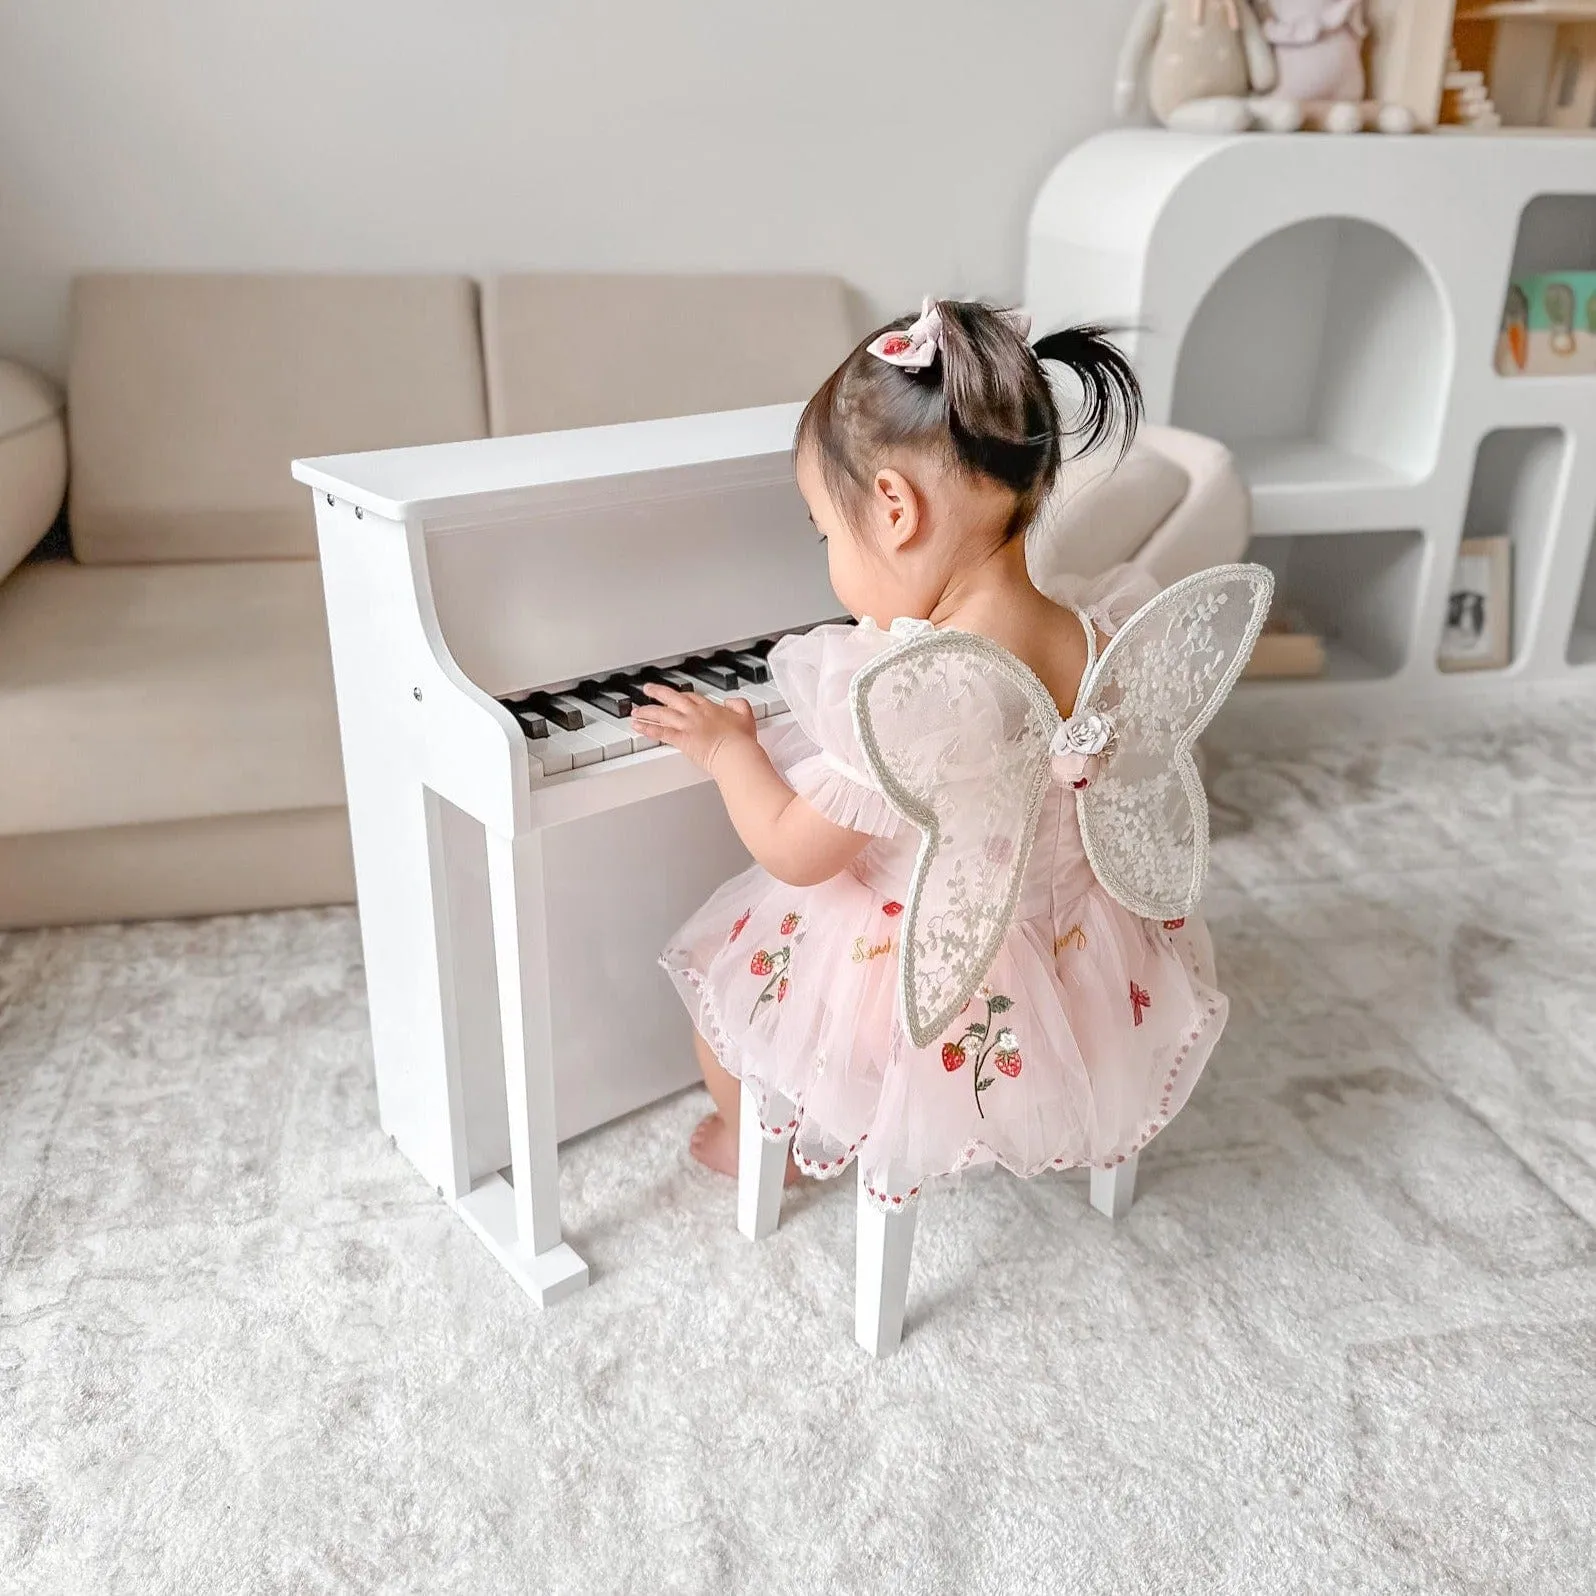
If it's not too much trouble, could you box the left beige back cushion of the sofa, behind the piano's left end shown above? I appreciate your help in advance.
[67,273,487,563]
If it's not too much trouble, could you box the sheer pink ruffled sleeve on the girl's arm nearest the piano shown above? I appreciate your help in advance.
[768,624,899,836]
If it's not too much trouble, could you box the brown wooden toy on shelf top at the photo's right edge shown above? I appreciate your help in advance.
[1443,0,1596,132]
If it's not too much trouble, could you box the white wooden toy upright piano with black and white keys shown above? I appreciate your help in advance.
[294,405,839,1304]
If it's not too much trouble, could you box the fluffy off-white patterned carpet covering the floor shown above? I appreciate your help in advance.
[0,699,1596,1596]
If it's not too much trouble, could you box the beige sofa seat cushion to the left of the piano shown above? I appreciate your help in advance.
[0,560,343,835]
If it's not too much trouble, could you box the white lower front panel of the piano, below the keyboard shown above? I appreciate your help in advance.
[544,782,749,1141]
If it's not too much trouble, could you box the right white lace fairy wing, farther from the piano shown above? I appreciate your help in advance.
[1074,565,1275,919]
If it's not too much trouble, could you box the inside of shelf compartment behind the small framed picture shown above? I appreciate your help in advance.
[1464,426,1569,659]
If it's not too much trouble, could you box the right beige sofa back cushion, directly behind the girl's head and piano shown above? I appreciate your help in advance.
[482,273,855,437]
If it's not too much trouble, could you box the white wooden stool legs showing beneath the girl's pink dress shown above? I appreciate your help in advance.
[737,1087,1136,1358]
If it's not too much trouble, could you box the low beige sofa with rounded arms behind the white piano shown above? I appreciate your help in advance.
[0,275,1246,926]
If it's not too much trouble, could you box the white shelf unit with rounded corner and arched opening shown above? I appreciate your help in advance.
[1025,129,1596,737]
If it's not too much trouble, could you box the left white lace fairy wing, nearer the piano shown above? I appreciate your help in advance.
[851,630,1060,1047]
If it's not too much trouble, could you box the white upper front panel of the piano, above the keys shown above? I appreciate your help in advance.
[426,472,841,696]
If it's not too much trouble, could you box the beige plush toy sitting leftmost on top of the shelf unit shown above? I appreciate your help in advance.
[1114,0,1302,132]
